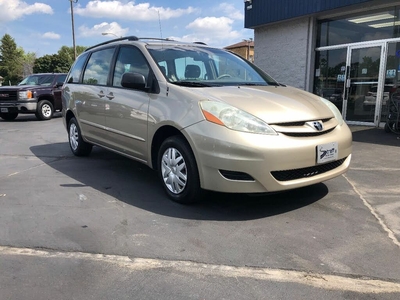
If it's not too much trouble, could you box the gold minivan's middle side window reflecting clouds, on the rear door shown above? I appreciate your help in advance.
[83,48,114,85]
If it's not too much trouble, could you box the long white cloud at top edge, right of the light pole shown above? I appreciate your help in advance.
[74,0,197,21]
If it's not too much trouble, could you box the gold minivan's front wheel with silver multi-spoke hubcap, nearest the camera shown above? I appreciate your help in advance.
[157,136,201,204]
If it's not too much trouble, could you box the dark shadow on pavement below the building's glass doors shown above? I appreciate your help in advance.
[350,126,400,147]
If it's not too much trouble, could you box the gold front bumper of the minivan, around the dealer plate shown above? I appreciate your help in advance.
[184,121,352,193]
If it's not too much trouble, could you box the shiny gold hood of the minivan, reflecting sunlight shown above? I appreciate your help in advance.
[198,86,334,124]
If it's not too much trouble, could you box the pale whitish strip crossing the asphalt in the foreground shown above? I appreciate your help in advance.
[0,246,400,294]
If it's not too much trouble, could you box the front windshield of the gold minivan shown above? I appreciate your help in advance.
[148,45,279,87]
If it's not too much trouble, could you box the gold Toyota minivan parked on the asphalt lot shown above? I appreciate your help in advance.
[62,36,352,203]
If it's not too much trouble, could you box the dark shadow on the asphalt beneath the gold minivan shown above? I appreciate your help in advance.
[30,143,328,221]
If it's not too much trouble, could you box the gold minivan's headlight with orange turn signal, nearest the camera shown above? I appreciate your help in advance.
[200,101,277,135]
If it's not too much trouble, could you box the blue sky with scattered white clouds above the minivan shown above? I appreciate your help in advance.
[0,0,253,57]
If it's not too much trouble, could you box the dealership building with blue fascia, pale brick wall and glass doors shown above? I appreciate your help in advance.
[244,0,400,127]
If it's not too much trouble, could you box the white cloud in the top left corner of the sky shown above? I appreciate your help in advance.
[0,0,53,23]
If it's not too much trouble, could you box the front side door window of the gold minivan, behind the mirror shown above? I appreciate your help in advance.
[113,47,150,86]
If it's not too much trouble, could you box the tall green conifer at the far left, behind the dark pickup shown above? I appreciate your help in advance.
[0,34,24,84]
